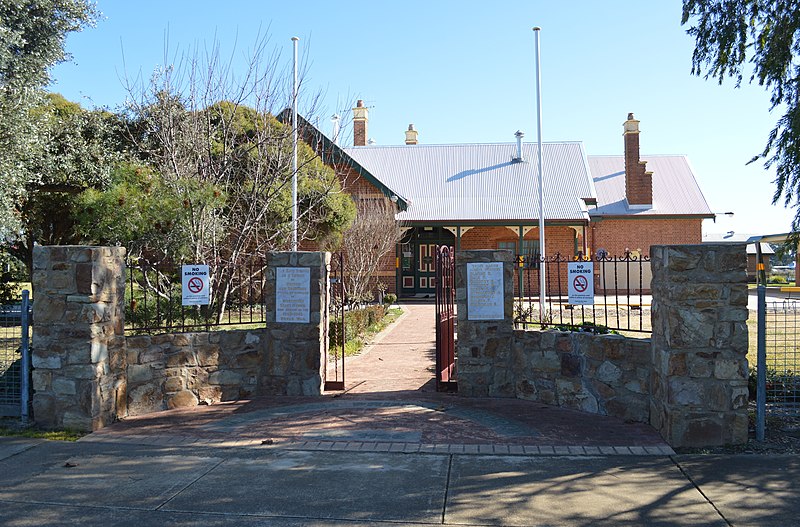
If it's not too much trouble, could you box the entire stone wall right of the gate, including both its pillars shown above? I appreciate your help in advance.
[456,244,748,447]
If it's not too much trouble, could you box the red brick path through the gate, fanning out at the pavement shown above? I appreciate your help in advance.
[82,303,672,455]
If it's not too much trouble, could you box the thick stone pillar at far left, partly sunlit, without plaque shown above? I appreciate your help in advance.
[32,246,126,431]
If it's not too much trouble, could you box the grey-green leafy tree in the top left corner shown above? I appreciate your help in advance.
[0,0,99,237]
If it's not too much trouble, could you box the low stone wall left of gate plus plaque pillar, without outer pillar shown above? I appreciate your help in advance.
[126,252,330,415]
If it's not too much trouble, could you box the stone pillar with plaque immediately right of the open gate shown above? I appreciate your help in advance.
[455,250,515,397]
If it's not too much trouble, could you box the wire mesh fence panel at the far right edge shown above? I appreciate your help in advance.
[764,300,800,417]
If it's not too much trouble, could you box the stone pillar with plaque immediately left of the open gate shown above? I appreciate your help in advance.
[259,252,331,395]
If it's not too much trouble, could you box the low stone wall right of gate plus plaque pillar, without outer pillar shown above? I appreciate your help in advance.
[456,250,651,422]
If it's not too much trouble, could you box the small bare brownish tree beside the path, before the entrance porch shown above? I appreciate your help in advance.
[343,198,403,302]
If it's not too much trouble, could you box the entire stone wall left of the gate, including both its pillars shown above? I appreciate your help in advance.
[32,246,330,430]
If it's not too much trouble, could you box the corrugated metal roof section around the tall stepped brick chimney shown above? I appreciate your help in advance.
[588,155,712,216]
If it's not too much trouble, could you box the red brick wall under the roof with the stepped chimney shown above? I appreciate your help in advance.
[591,218,703,256]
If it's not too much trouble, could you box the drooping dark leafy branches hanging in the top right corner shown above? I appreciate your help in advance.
[681,0,800,232]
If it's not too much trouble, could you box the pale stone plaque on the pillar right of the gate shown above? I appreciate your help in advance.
[467,262,505,320]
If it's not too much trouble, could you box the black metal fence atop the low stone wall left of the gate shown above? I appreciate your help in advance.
[125,258,266,335]
